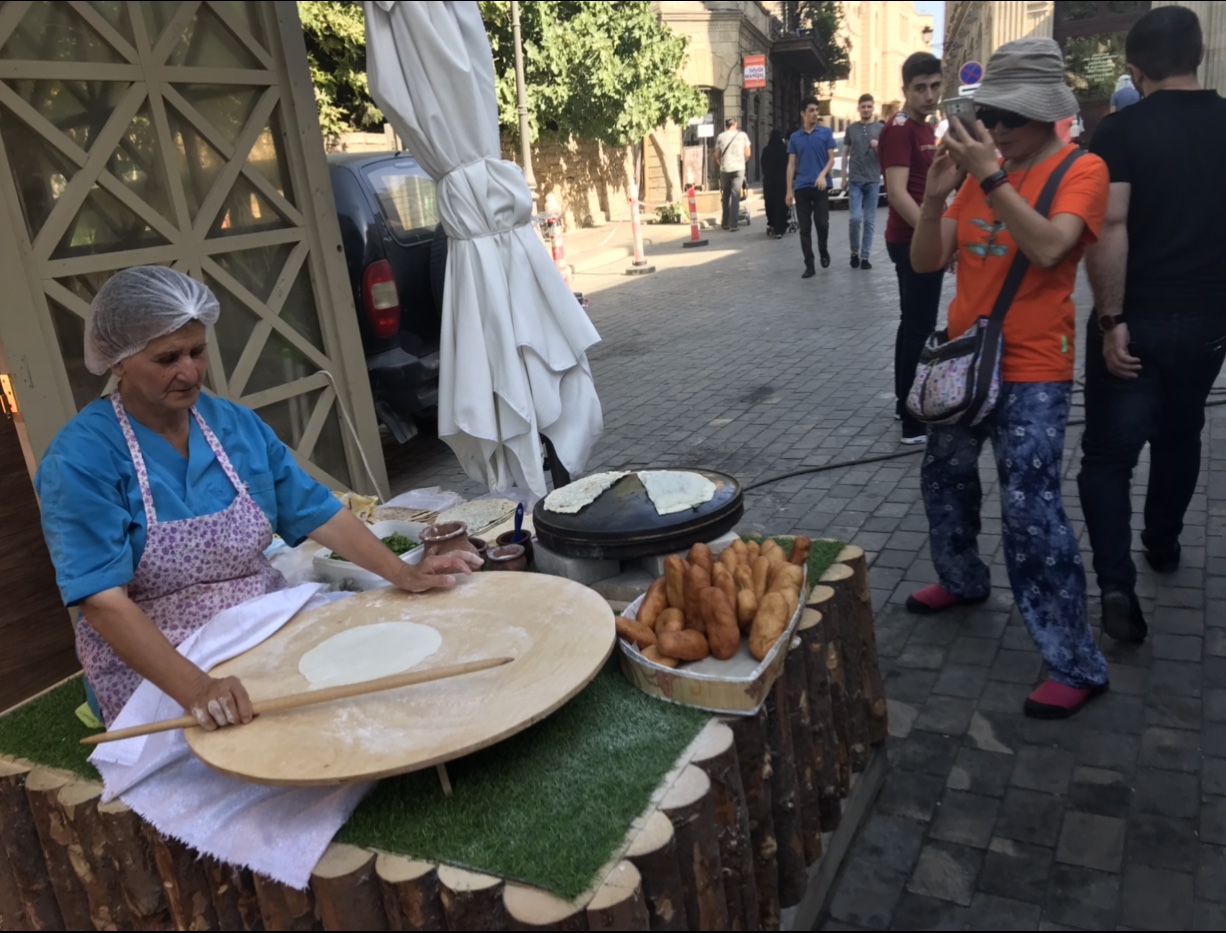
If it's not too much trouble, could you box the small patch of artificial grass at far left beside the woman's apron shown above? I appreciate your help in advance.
[0,674,99,781]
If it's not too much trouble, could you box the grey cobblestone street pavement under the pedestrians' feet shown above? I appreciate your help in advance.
[390,211,1226,929]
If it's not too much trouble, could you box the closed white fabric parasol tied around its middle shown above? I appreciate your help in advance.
[365,0,603,495]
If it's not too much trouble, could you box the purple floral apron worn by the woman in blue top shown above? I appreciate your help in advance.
[76,392,287,726]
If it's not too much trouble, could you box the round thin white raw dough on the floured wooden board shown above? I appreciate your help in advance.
[298,622,443,690]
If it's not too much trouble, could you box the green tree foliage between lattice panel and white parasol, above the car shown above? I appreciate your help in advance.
[298,0,384,136]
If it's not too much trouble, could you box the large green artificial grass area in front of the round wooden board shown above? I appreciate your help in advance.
[337,657,711,899]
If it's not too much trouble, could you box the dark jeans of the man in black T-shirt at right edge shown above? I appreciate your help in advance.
[1078,310,1226,592]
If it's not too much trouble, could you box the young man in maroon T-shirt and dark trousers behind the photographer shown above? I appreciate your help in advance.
[877,51,945,444]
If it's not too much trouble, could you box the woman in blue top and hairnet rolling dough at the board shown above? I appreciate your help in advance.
[34,266,478,729]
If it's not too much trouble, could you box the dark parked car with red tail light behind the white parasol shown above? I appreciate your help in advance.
[327,152,447,444]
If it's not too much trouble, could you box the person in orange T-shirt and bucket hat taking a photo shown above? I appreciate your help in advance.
[907,38,1107,718]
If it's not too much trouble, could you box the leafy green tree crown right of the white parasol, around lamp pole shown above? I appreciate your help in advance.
[481,0,706,146]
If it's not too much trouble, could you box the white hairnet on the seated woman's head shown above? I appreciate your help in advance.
[85,266,221,375]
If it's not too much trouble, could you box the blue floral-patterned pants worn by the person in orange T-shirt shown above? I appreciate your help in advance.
[921,383,1107,688]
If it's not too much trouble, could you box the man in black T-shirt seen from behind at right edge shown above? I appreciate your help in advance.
[1078,6,1226,641]
